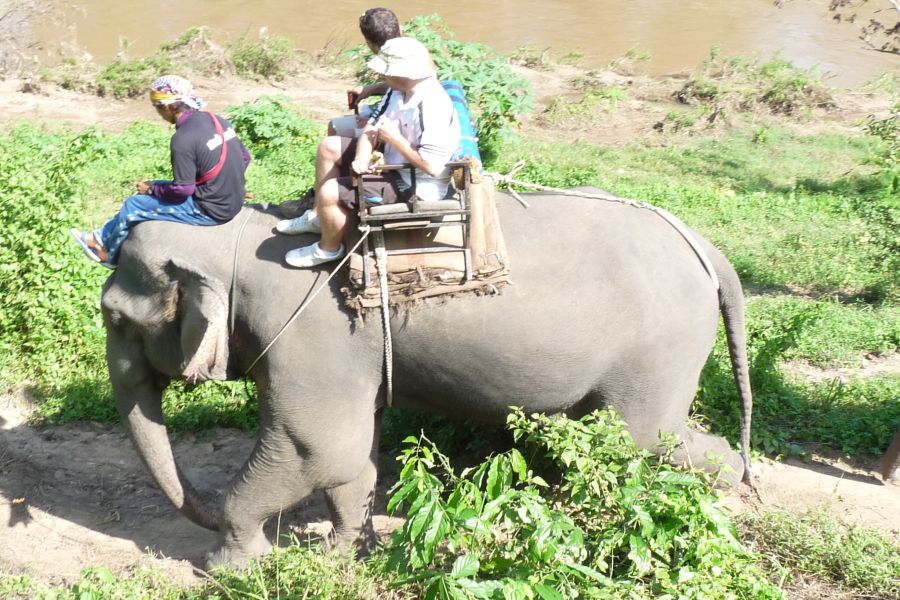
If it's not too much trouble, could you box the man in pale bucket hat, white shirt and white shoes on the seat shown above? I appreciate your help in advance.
[277,37,460,267]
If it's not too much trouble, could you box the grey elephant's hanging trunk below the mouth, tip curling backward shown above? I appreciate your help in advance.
[116,383,219,531]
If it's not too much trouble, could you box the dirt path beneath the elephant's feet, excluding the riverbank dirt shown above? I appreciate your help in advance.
[0,378,900,584]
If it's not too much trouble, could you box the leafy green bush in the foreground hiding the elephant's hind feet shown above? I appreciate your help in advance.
[388,411,780,599]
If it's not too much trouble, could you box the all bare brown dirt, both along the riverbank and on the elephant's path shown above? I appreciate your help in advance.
[0,23,900,583]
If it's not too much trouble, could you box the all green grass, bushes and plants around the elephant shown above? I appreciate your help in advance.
[0,17,900,600]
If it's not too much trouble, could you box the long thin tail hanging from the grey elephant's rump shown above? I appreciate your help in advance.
[707,245,753,485]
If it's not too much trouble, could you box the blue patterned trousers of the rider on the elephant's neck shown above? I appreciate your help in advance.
[94,189,219,264]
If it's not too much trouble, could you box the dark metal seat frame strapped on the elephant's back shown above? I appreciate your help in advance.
[356,161,472,287]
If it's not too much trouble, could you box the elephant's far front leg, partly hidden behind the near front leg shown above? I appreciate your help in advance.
[325,410,382,558]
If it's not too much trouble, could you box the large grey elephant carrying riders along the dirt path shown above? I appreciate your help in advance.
[101,193,752,565]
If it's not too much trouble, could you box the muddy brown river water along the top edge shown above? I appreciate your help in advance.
[35,0,900,86]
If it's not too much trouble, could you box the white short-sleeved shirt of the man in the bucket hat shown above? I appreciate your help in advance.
[369,77,460,201]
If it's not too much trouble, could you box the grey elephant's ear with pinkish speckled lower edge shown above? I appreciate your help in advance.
[165,260,228,383]
